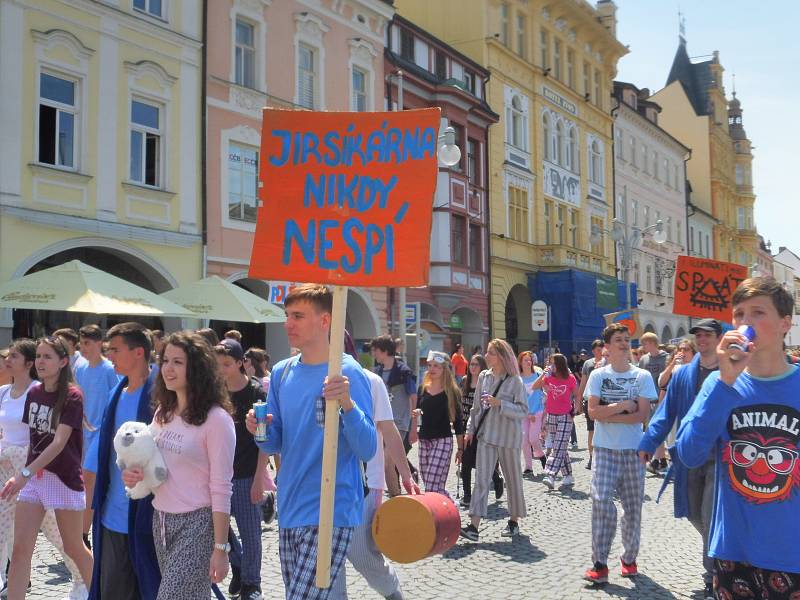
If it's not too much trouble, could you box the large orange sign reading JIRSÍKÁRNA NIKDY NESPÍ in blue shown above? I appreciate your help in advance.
[249,108,441,286]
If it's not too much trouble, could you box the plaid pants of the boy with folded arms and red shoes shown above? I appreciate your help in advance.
[590,446,644,564]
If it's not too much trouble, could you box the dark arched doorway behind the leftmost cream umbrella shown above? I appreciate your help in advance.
[12,240,181,338]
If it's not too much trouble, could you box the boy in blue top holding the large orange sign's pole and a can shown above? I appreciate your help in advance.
[247,284,377,600]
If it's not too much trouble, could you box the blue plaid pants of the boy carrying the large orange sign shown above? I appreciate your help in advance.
[278,527,353,600]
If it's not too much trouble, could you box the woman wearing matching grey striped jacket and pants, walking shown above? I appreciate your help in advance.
[461,339,528,542]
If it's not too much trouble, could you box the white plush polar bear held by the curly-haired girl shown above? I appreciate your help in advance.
[114,421,167,500]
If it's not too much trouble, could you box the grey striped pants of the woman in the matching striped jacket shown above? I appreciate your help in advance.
[469,440,527,517]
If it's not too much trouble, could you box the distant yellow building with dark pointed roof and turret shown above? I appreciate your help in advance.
[651,37,758,267]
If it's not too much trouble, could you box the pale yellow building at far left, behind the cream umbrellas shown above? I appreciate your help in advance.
[0,0,203,343]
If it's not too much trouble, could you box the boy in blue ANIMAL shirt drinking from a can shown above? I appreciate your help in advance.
[676,277,800,600]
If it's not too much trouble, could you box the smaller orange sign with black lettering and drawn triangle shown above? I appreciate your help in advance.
[672,256,747,321]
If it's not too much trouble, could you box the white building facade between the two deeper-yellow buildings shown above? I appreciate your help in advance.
[612,82,689,342]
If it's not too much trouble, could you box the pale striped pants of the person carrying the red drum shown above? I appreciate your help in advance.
[331,488,400,600]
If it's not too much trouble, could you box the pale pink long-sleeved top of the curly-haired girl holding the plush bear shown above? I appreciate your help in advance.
[153,406,236,514]
